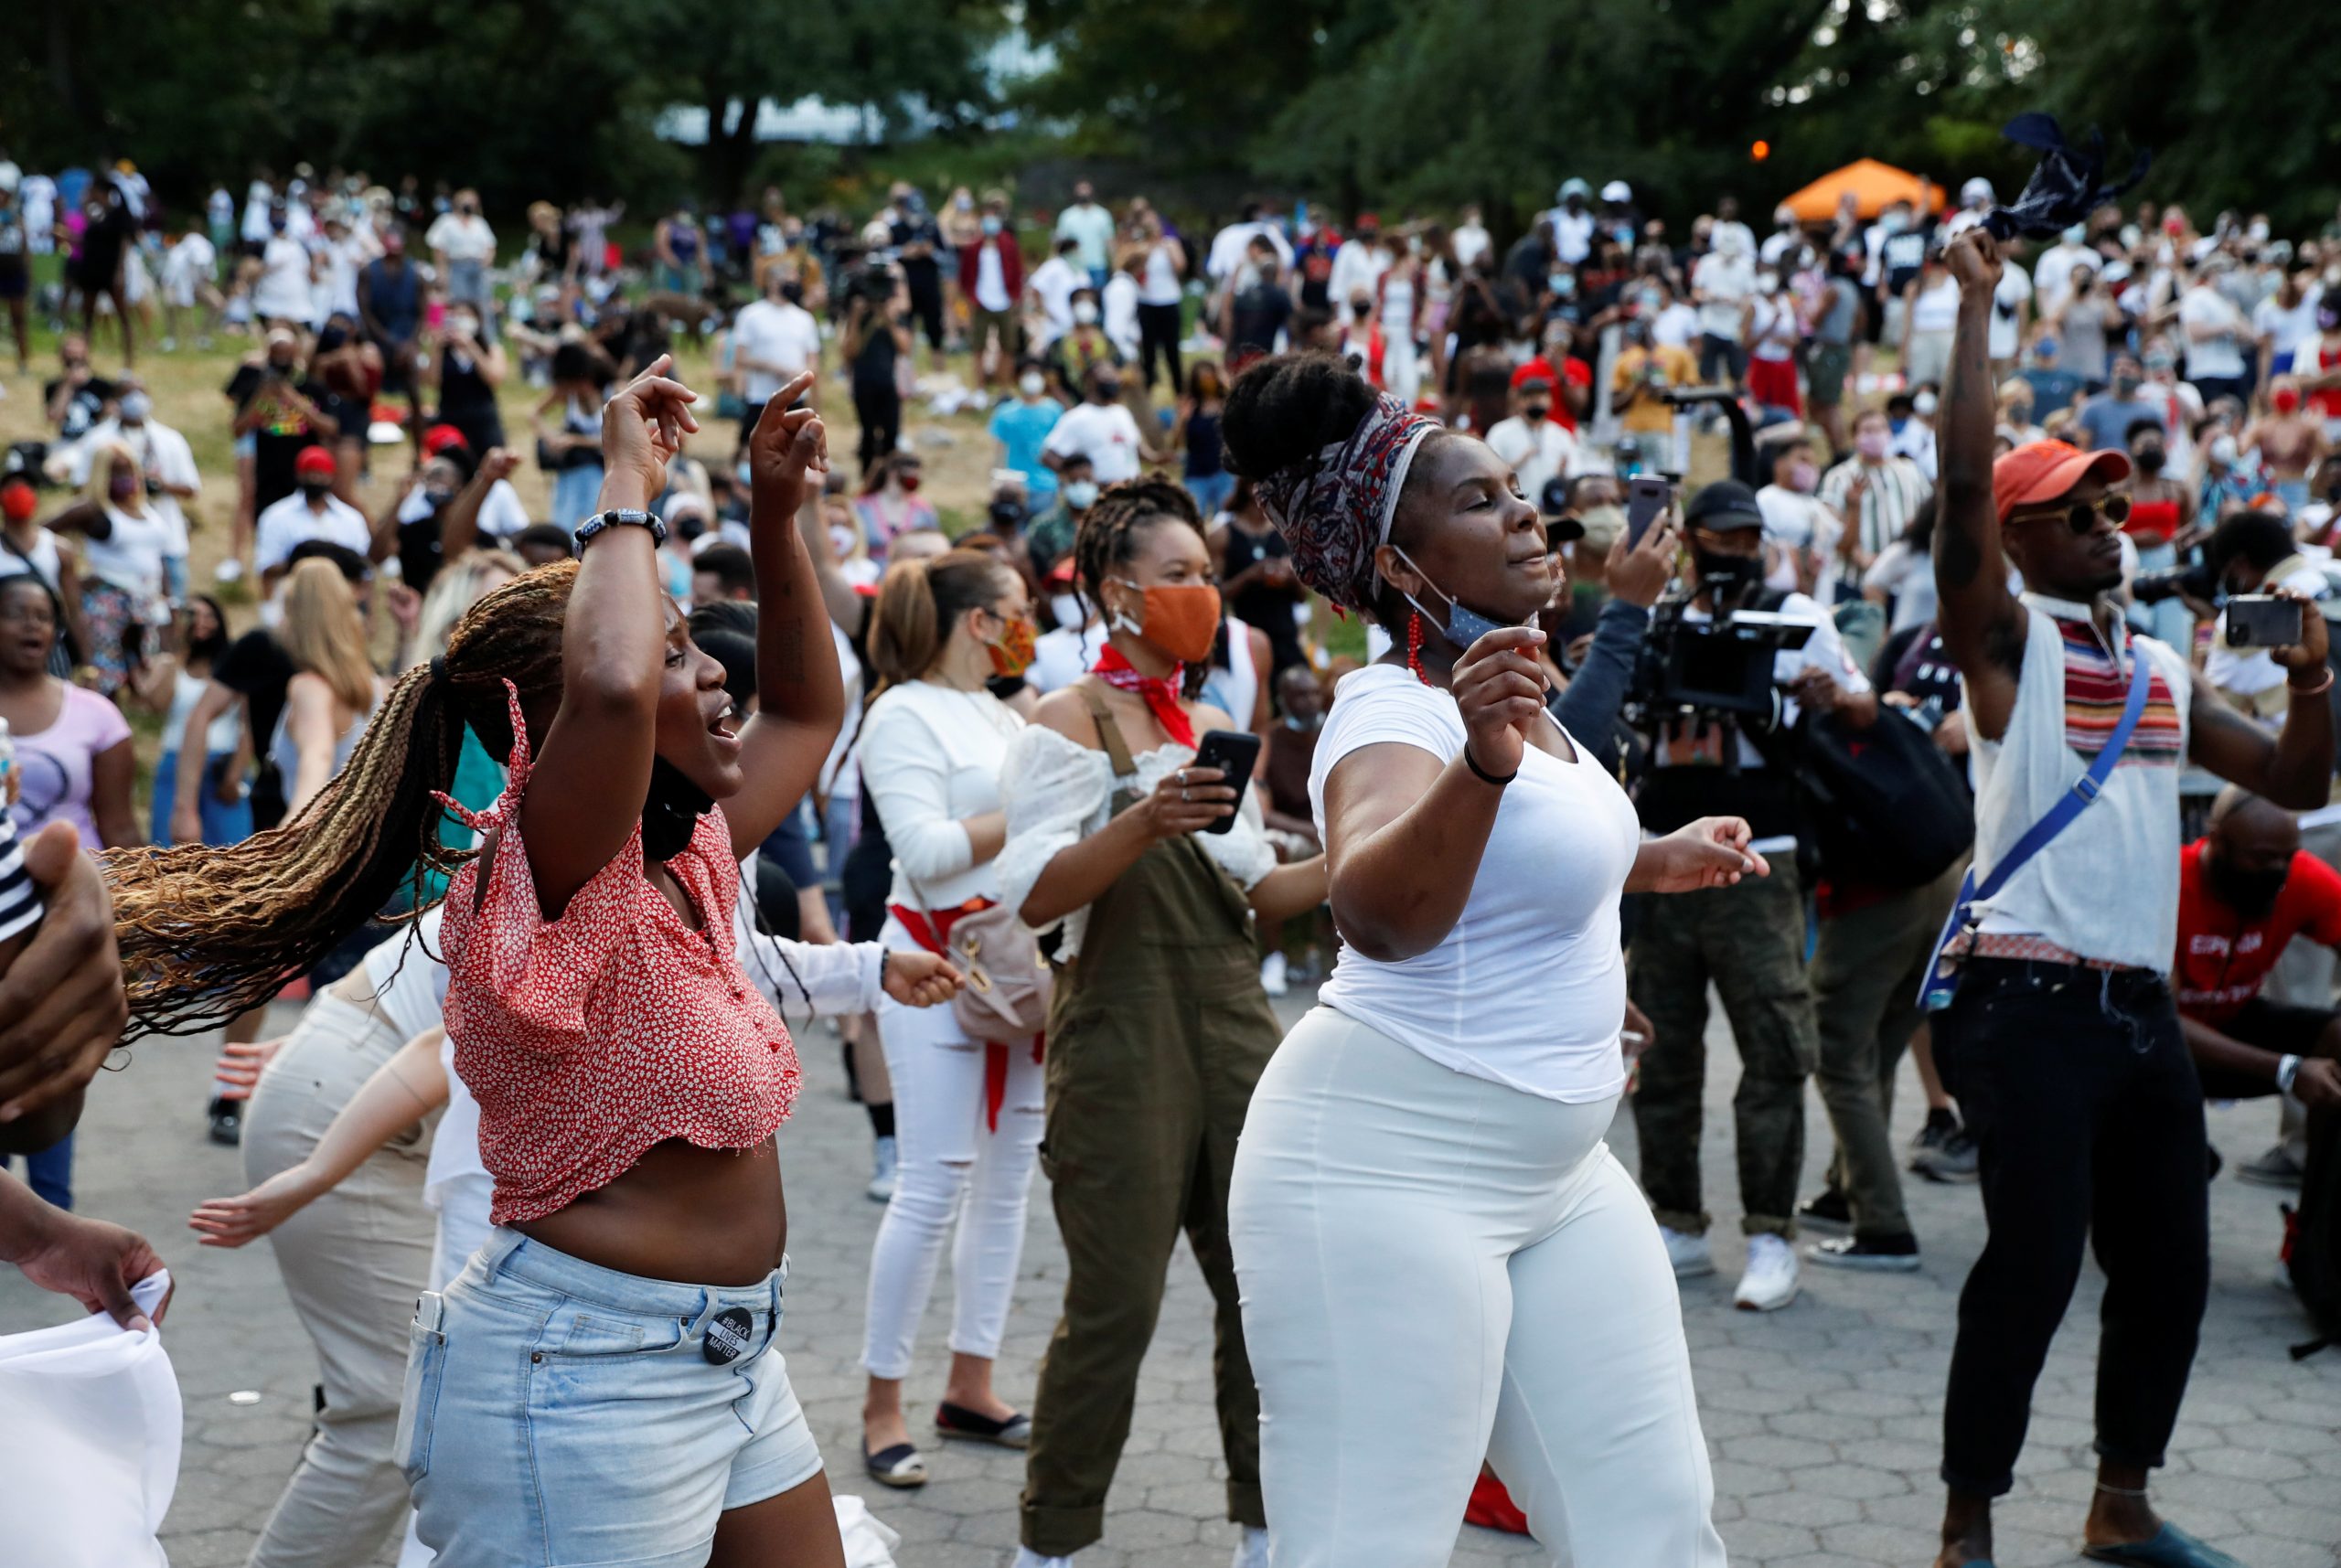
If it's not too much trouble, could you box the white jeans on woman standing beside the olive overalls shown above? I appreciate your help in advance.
[861,915,1042,1379]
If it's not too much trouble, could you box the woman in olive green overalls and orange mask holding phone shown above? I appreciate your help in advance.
[999,480,1325,1568]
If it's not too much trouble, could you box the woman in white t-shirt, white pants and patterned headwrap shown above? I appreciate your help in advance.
[1217,354,1768,1568]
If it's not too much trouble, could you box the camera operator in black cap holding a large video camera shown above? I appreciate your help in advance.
[1627,480,1877,1310]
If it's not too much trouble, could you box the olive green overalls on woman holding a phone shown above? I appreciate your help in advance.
[1023,686,1283,1556]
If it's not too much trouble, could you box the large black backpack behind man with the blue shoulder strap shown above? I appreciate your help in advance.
[1796,702,1976,887]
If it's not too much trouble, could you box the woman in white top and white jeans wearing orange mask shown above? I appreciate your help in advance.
[860,550,1042,1486]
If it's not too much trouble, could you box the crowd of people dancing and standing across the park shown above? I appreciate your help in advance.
[0,151,2341,1568]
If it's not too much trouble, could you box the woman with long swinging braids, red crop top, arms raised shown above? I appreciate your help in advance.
[110,358,843,1568]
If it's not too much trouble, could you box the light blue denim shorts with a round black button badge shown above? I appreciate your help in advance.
[391,1226,822,1568]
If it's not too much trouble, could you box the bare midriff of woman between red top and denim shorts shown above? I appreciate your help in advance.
[513,1137,789,1285]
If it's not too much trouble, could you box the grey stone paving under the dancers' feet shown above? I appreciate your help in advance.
[0,997,2341,1568]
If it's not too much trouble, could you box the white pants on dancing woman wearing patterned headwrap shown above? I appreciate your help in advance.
[1229,1007,1723,1568]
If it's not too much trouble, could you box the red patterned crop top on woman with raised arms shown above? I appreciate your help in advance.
[443,695,798,1224]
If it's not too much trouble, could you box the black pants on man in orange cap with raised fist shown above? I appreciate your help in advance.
[1934,959,2210,1498]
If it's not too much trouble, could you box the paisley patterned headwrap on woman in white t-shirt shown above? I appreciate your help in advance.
[1257,393,1439,611]
